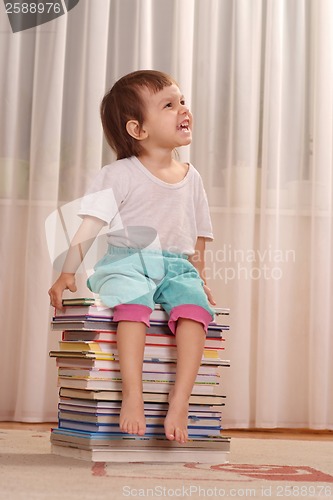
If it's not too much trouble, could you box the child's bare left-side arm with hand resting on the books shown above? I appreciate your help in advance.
[48,216,105,309]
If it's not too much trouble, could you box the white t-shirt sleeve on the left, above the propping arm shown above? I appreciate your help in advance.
[78,164,126,224]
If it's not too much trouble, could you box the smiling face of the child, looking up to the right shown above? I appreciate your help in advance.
[142,84,192,150]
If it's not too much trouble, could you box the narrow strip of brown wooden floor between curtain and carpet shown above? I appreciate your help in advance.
[0,422,333,441]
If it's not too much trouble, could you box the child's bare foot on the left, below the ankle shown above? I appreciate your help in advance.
[119,394,146,436]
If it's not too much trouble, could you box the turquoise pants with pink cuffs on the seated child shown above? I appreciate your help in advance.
[88,247,214,331]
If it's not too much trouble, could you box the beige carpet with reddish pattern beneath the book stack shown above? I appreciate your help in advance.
[0,430,333,500]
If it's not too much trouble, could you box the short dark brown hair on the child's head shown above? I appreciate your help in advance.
[101,70,177,160]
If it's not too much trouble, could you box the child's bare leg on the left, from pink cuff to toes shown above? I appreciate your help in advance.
[117,321,146,436]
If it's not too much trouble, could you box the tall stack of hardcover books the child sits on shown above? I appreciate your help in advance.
[50,299,230,463]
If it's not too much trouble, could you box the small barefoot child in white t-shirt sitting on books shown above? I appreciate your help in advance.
[49,70,215,443]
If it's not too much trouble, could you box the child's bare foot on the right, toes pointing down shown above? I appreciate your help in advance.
[164,392,189,444]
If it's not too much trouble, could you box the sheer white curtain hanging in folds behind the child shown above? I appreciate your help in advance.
[0,0,333,429]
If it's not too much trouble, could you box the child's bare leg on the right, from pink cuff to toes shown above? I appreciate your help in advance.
[164,318,206,443]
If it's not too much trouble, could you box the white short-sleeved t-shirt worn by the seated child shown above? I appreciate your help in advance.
[79,156,213,255]
